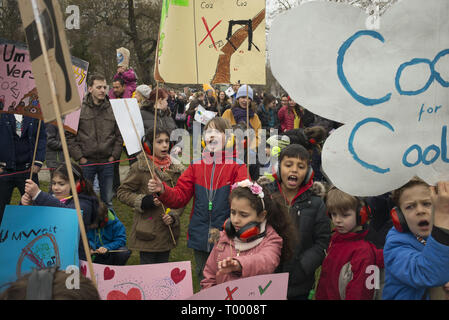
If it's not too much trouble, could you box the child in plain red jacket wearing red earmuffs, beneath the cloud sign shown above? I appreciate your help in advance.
[316,188,384,300]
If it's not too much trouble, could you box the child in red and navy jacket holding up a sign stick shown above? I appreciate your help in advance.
[148,117,247,280]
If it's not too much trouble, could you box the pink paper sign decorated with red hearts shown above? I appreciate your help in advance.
[80,261,193,300]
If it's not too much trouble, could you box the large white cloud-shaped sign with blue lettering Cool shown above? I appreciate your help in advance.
[268,0,449,196]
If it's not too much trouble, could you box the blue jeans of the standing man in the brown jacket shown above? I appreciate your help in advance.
[82,161,114,208]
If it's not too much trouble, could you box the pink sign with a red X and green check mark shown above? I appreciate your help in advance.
[189,273,288,300]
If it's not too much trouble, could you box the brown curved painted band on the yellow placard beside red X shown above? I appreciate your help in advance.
[211,9,265,84]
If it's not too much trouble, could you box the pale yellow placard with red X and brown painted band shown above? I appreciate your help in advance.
[155,0,265,84]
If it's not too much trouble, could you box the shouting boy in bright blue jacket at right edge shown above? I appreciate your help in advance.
[382,178,449,300]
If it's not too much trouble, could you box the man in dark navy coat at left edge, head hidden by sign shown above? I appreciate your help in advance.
[0,113,47,223]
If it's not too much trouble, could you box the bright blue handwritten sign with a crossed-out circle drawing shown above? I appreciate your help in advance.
[0,206,79,290]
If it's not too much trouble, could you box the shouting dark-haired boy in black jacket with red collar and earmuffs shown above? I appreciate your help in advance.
[267,144,331,300]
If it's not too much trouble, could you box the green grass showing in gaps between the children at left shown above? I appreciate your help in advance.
[7,181,200,292]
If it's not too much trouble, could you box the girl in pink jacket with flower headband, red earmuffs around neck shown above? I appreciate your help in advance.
[201,180,293,289]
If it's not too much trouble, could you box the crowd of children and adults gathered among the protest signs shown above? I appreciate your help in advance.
[0,50,449,300]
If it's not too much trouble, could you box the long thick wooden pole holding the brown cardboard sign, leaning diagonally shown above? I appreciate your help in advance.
[32,0,98,288]
